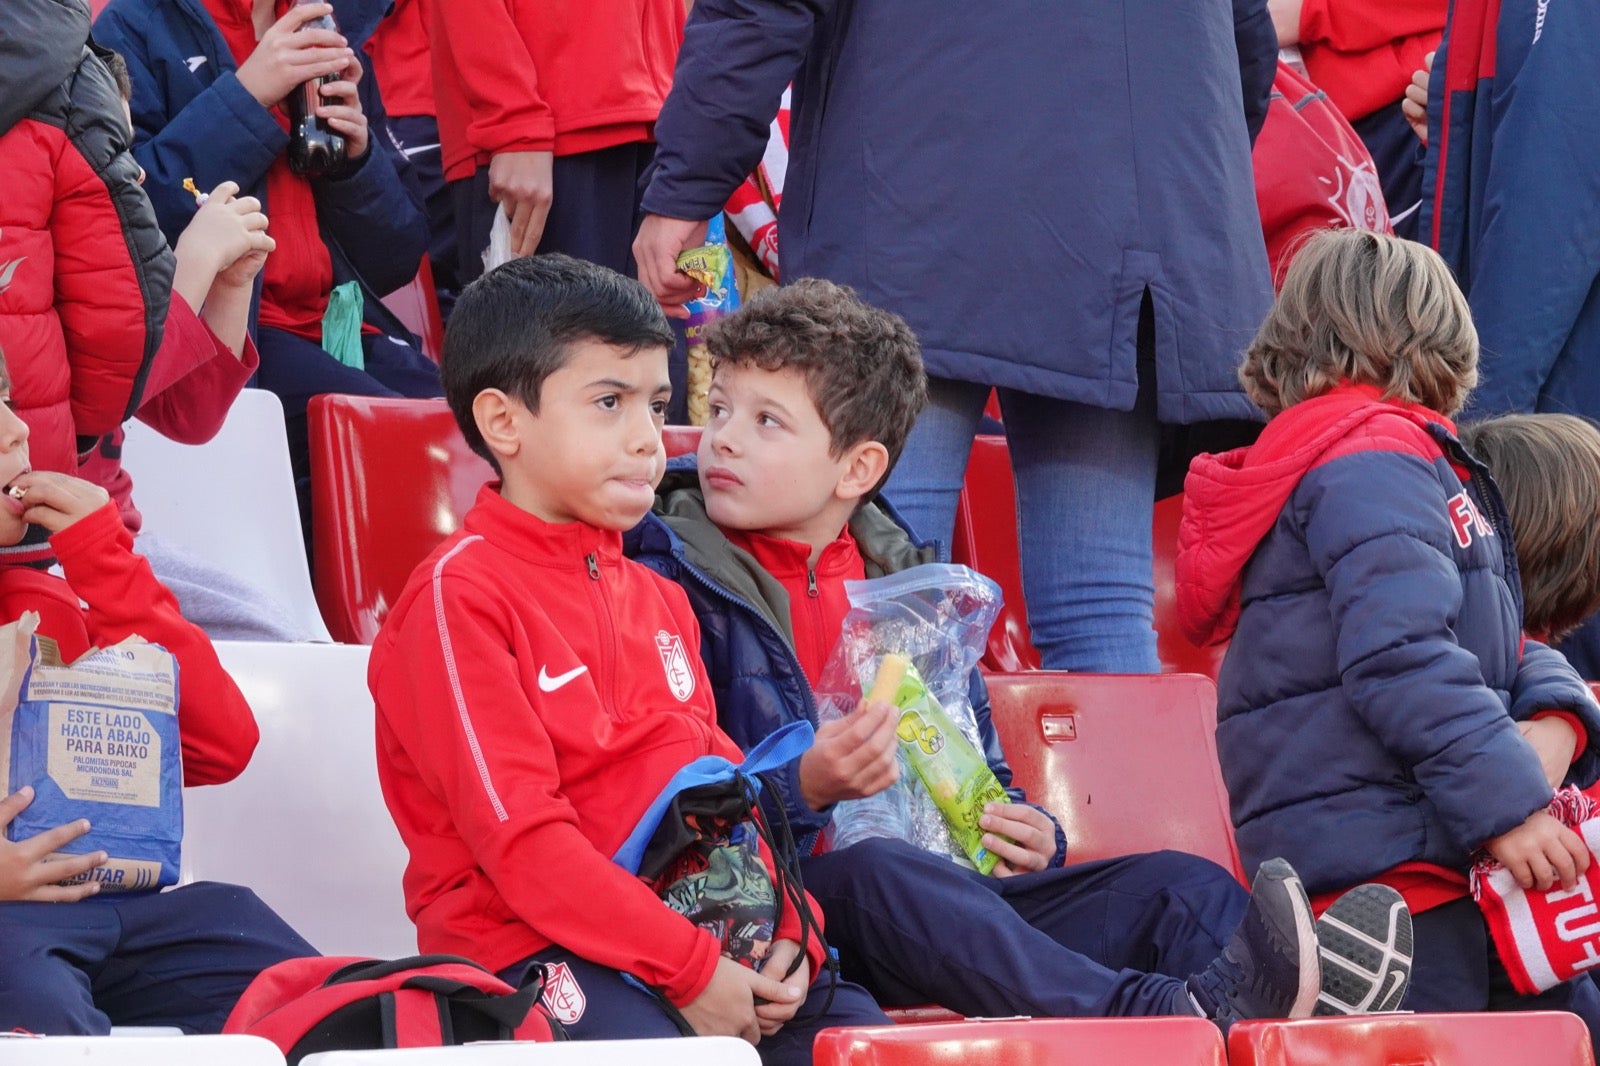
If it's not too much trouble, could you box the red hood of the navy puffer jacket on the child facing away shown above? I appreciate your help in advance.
[1174,386,1454,647]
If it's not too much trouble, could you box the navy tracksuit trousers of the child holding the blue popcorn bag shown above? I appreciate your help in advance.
[0,882,317,1036]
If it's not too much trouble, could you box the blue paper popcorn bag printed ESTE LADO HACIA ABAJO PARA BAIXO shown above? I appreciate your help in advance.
[0,611,184,892]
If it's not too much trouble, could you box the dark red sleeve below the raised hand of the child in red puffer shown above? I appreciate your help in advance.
[138,293,261,445]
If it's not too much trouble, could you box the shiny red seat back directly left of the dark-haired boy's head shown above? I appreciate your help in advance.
[309,395,699,643]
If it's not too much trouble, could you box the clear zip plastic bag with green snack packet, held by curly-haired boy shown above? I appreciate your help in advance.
[818,563,1006,872]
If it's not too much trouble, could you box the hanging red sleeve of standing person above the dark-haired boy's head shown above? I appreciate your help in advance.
[427,0,555,155]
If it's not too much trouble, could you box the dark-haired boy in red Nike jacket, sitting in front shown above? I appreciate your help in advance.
[368,256,885,1064]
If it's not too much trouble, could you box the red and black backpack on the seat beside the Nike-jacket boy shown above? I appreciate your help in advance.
[222,956,566,1066]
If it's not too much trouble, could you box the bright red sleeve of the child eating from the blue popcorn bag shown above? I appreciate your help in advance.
[50,503,261,784]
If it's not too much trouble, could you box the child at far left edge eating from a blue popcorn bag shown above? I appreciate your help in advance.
[0,344,317,1036]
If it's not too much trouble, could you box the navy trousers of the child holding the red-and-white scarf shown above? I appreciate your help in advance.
[1400,900,1600,1047]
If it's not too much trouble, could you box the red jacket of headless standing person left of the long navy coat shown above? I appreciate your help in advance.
[421,0,683,181]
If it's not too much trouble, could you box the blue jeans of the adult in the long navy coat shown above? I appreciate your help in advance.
[885,378,1162,674]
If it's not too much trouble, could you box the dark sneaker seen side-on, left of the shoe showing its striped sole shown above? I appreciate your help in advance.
[1186,860,1322,1029]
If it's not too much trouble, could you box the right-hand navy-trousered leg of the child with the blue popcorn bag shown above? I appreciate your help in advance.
[94,882,318,1032]
